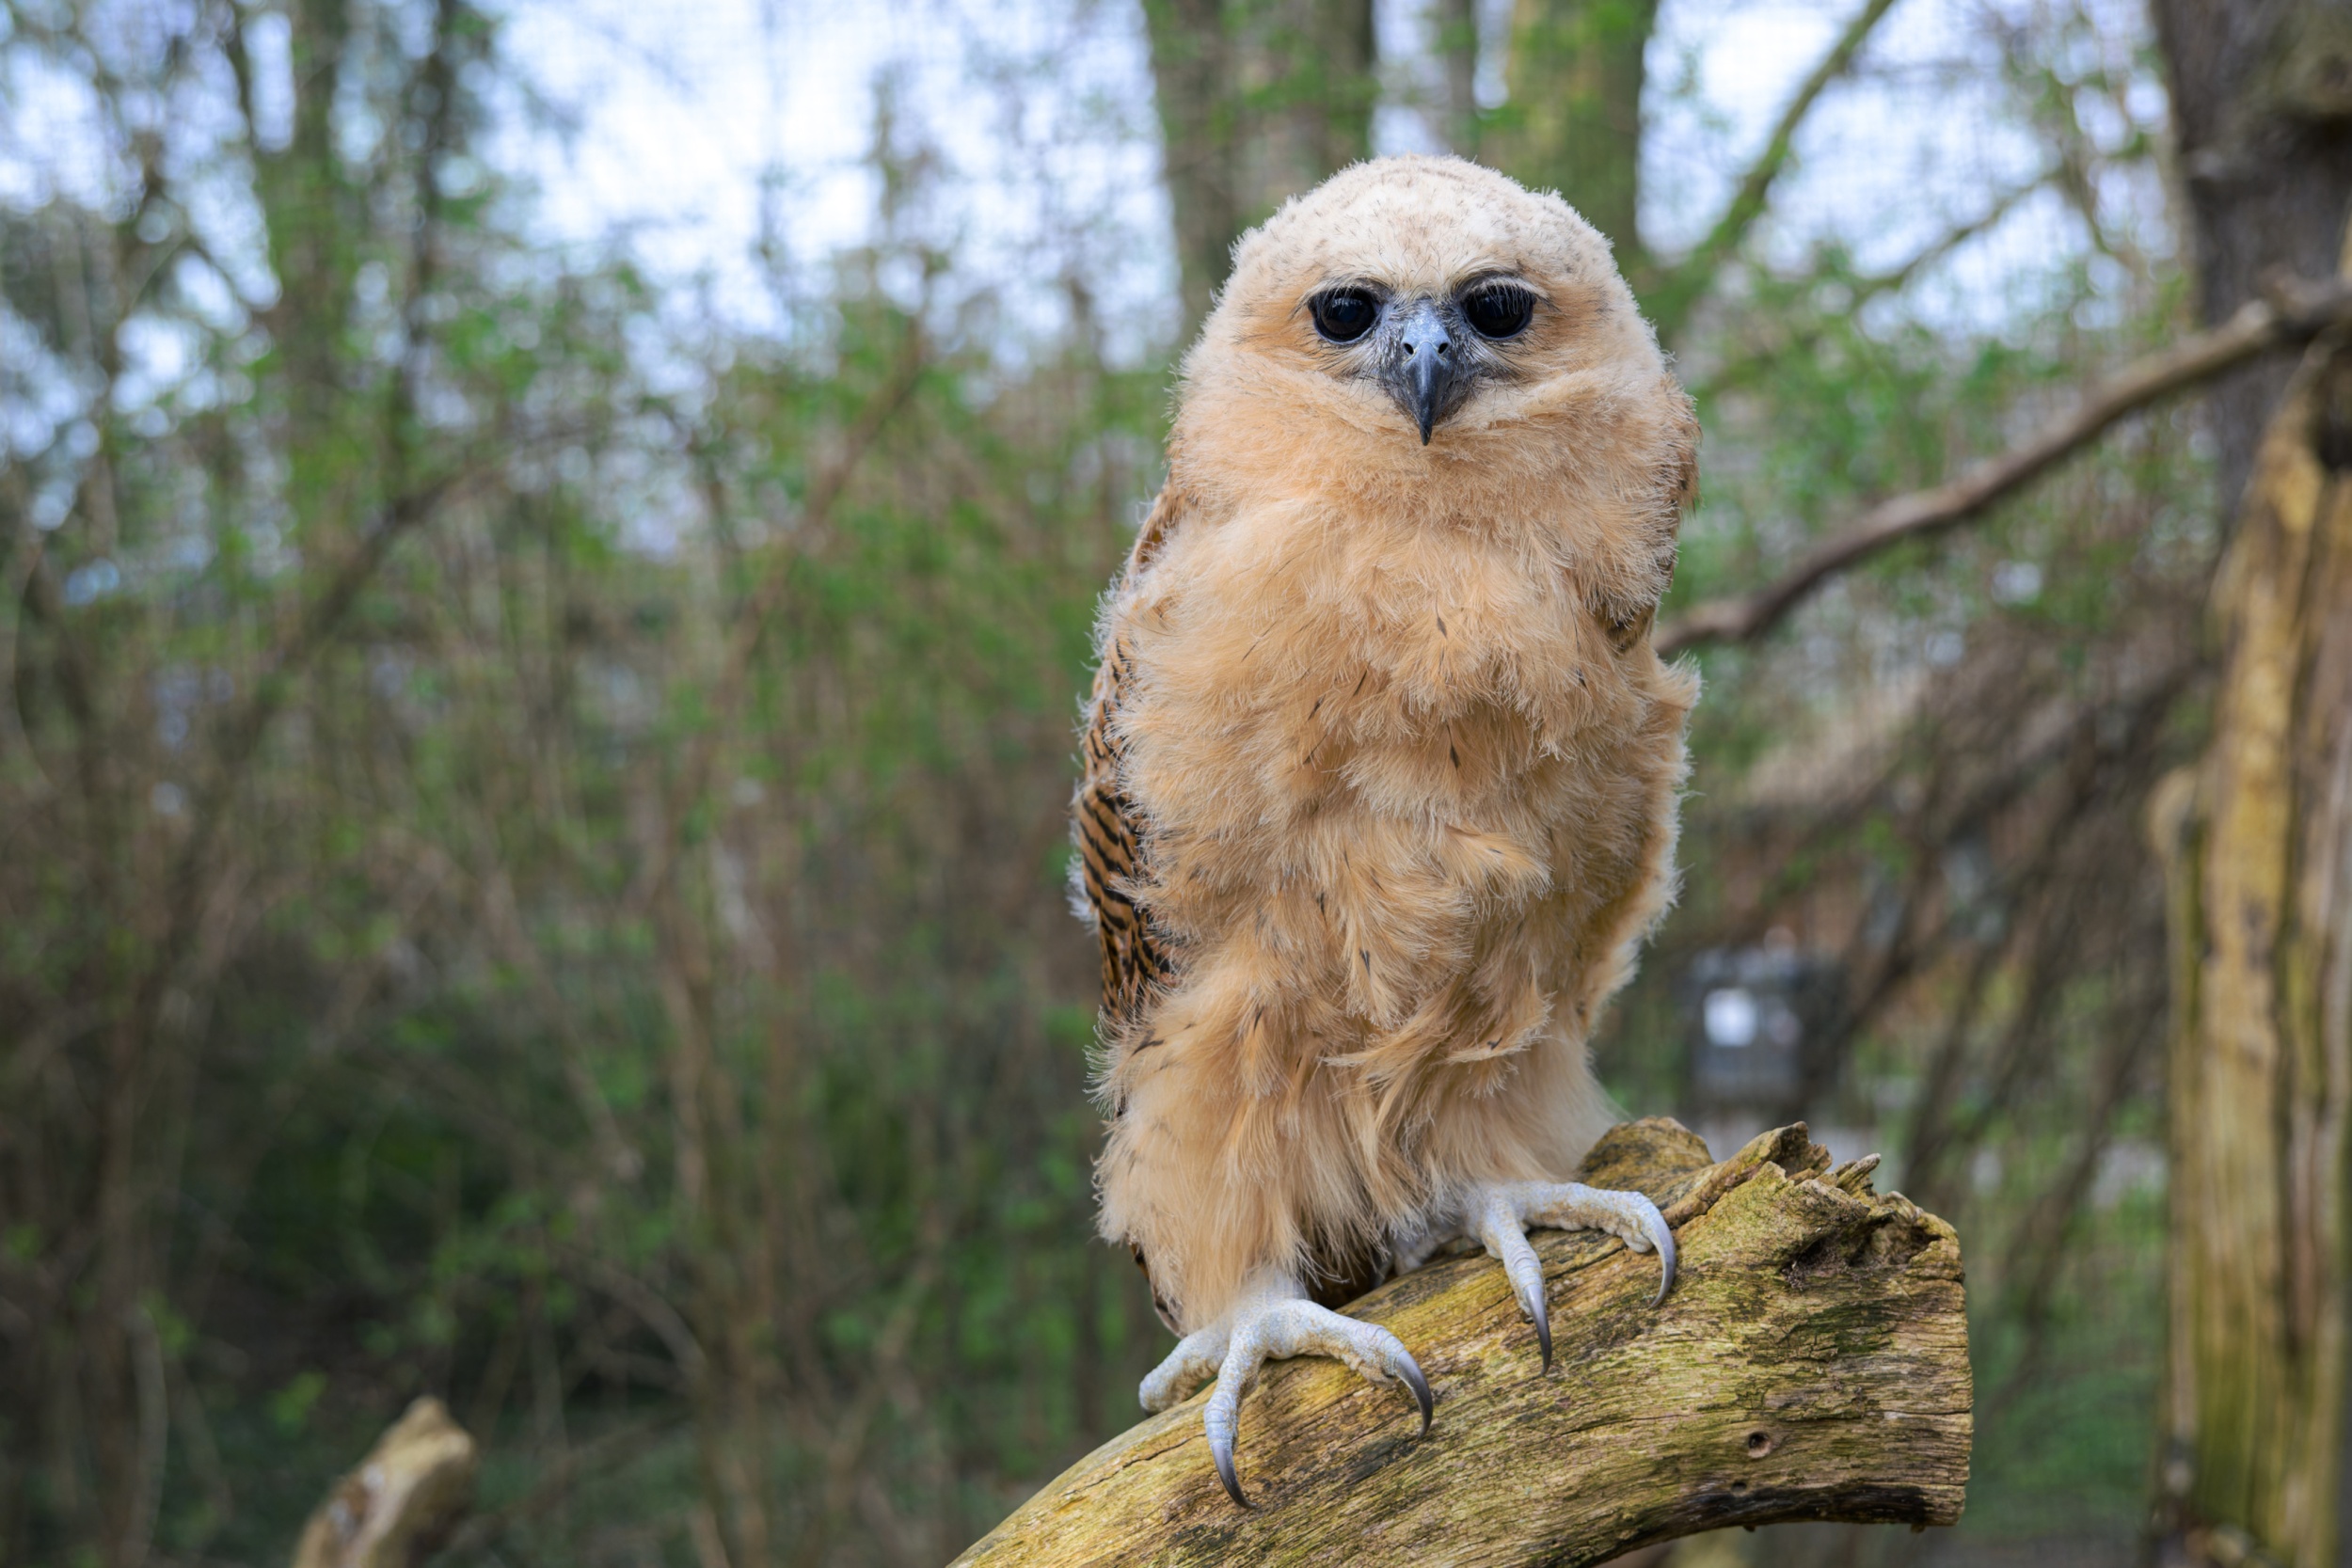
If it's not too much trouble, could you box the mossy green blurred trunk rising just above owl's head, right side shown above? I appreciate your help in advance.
[1480,0,1659,289]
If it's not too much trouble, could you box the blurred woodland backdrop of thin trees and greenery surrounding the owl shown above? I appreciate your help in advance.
[0,0,2343,1568]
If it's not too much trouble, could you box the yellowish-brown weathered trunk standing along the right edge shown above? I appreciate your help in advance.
[2157,329,2352,1568]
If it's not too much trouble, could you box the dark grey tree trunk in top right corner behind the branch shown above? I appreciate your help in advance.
[2150,0,2352,505]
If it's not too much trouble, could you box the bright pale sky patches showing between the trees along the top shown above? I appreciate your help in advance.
[0,0,2164,385]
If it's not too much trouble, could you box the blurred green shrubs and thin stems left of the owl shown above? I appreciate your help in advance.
[0,2,1165,1563]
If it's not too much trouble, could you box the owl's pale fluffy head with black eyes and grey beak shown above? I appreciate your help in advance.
[1185,157,1679,463]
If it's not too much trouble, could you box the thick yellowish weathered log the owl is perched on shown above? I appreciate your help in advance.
[955,1119,1971,1568]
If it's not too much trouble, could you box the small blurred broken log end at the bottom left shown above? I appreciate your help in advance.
[294,1399,475,1568]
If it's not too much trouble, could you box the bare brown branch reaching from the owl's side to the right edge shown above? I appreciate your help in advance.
[1656,282,2352,654]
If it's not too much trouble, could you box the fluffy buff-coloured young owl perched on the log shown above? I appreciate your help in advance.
[1073,157,1698,1507]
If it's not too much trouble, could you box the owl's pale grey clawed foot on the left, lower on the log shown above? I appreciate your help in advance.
[1141,1275,1435,1510]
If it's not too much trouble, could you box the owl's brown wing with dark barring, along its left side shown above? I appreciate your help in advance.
[1071,484,1184,1022]
